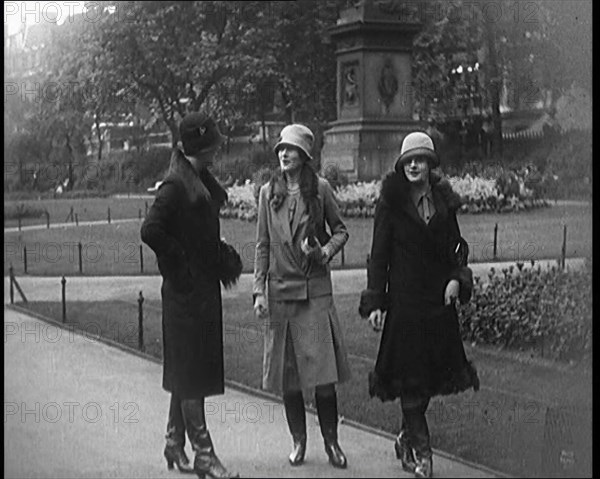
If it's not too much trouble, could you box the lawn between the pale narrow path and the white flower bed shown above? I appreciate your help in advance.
[4,200,592,276]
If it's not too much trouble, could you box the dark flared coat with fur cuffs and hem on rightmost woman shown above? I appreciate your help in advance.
[359,172,479,401]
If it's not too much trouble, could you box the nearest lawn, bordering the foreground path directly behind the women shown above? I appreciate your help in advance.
[22,295,592,476]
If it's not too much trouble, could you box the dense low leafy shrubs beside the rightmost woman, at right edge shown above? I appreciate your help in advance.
[459,262,592,360]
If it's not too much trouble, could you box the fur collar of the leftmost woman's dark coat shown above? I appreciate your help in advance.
[165,148,227,206]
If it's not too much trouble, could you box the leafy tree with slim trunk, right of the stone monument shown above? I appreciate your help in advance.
[413,0,566,159]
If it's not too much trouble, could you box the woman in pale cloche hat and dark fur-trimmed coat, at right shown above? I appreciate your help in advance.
[359,132,479,477]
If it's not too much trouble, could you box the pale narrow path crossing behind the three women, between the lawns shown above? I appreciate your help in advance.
[4,258,584,304]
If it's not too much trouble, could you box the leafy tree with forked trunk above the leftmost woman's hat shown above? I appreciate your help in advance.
[91,2,278,145]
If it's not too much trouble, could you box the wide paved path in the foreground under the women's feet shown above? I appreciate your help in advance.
[4,309,502,479]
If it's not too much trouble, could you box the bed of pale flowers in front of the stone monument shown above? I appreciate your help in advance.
[221,172,548,221]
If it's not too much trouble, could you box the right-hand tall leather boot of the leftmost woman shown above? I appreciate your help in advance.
[182,399,239,479]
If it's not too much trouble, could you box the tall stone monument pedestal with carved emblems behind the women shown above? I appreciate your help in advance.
[321,0,424,181]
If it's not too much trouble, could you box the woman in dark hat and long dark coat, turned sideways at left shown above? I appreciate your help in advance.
[141,113,242,478]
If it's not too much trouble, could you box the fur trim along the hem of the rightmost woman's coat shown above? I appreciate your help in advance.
[369,361,480,402]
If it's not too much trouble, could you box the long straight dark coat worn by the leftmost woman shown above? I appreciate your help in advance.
[141,149,227,399]
